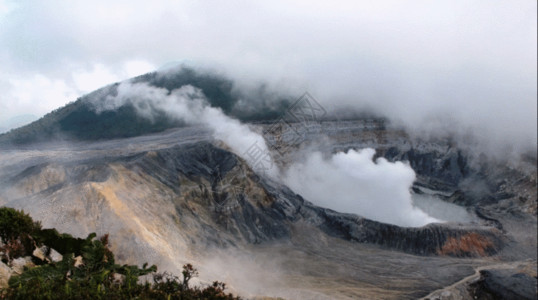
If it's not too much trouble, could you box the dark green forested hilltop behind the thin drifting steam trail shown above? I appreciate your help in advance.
[0,67,289,145]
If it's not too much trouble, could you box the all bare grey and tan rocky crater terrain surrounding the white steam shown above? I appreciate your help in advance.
[0,120,537,299]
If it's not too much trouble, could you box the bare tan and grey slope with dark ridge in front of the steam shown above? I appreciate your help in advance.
[0,128,528,299]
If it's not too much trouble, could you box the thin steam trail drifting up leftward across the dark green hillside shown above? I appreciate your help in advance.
[93,82,278,177]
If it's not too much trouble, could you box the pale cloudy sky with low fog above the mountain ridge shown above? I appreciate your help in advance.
[0,0,537,155]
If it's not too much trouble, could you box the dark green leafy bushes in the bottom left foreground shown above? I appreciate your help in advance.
[0,207,239,300]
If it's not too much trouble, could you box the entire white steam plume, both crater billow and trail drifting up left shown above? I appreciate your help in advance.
[94,83,439,226]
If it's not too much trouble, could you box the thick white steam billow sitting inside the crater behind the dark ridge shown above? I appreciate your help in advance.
[284,148,440,227]
